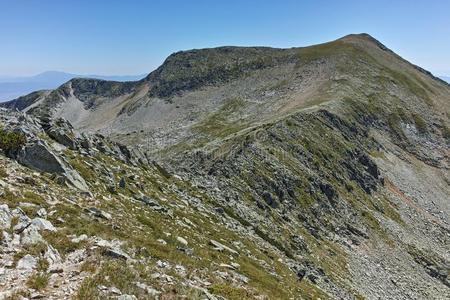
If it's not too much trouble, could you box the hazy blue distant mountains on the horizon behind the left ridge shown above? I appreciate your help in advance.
[0,71,145,101]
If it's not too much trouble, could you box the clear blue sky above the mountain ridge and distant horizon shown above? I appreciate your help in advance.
[0,0,450,75]
